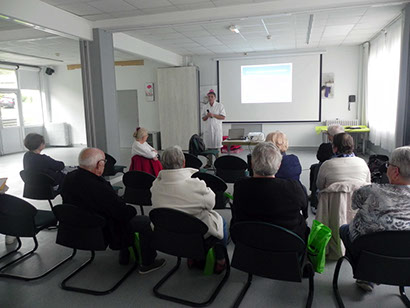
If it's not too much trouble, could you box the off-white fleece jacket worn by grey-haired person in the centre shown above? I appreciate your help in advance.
[151,168,223,239]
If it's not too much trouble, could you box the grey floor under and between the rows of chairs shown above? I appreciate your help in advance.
[0,148,404,308]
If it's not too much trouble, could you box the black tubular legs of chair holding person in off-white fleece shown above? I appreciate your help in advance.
[153,248,231,307]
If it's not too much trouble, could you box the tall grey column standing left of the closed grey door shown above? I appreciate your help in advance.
[80,29,120,160]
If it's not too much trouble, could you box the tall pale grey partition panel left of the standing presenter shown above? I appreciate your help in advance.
[157,67,200,150]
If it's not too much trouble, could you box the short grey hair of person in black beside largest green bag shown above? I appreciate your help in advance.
[252,142,282,176]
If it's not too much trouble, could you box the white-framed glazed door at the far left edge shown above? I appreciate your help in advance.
[0,90,24,155]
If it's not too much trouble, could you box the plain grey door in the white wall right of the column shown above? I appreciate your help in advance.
[117,90,139,148]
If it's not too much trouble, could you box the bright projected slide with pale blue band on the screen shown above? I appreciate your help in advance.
[241,63,292,104]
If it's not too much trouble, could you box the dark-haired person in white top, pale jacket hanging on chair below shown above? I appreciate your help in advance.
[316,133,370,190]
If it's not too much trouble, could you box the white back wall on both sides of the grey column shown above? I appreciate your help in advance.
[48,60,163,144]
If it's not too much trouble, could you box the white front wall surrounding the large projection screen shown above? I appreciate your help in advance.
[193,46,359,146]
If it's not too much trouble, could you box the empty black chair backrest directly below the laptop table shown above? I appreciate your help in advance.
[214,155,248,183]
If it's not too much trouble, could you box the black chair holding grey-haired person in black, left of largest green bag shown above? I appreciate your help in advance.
[231,222,314,307]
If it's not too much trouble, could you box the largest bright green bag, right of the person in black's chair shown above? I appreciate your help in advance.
[307,220,332,273]
